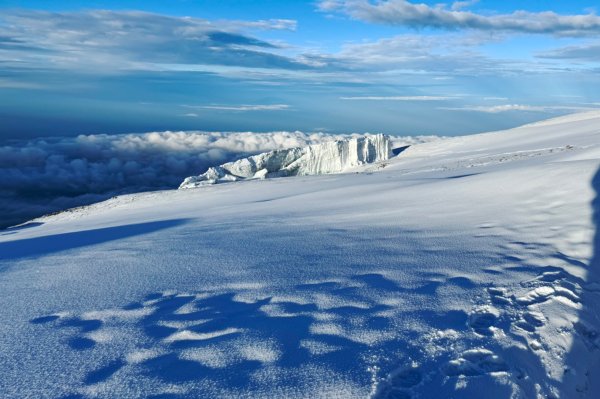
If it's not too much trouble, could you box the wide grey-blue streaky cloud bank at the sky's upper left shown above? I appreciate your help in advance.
[0,10,309,73]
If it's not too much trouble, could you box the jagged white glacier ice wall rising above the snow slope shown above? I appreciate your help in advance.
[179,134,392,188]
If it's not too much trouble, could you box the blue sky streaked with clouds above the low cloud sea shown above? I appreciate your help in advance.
[0,0,600,141]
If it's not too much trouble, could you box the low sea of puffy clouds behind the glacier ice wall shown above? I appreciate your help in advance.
[0,131,436,228]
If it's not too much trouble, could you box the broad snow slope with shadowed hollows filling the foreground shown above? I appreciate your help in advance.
[0,113,600,398]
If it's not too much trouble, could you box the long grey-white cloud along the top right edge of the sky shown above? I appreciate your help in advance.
[318,0,600,36]
